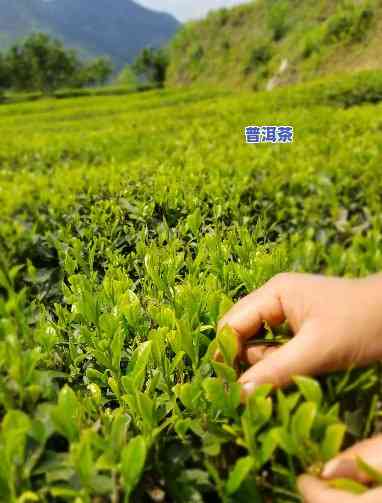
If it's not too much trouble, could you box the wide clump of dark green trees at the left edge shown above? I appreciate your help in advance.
[0,33,112,94]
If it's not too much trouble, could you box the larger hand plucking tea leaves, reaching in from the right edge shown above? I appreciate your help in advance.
[218,273,382,394]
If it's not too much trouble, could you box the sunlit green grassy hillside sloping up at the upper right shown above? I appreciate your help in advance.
[168,0,382,89]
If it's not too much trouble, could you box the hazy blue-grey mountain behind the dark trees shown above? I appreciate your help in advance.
[0,0,179,66]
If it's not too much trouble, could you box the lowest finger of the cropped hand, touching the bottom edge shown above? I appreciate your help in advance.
[297,475,355,503]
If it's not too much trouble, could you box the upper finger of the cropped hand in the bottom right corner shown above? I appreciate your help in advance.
[322,435,382,483]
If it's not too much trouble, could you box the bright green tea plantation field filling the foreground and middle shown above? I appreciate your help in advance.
[0,73,382,503]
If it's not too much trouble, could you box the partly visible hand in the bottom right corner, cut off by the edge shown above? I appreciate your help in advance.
[298,435,382,503]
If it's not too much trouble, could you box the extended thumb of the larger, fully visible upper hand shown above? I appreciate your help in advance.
[239,322,328,395]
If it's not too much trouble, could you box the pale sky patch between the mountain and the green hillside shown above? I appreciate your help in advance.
[135,0,248,21]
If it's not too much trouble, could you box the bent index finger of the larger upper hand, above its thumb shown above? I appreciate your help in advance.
[218,280,285,339]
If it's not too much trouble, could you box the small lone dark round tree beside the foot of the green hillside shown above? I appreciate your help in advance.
[132,48,169,87]
